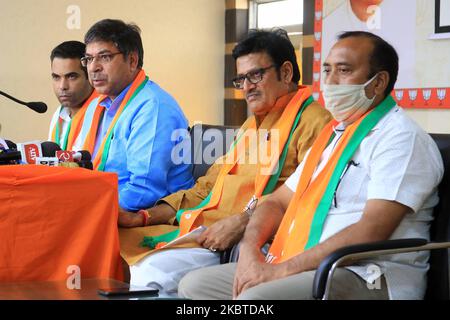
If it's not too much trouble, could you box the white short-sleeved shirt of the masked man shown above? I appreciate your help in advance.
[286,106,442,299]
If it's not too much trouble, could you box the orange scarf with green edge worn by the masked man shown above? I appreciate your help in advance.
[266,96,395,263]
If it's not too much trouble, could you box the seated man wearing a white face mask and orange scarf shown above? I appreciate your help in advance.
[179,32,443,299]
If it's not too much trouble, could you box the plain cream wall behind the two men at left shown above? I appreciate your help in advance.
[0,0,225,142]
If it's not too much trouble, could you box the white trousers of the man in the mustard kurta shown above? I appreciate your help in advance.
[130,248,220,296]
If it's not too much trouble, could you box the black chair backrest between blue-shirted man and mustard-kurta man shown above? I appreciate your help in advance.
[190,124,239,180]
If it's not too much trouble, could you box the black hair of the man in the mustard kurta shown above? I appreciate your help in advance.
[232,28,300,84]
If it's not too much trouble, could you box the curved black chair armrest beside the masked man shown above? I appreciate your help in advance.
[313,238,428,299]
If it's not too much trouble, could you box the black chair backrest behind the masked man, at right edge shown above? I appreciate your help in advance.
[425,134,450,300]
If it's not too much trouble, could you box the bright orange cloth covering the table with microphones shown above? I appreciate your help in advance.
[0,165,123,281]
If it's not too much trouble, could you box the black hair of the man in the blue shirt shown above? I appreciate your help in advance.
[84,19,144,68]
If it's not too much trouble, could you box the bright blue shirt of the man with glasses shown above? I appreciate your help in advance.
[81,80,194,211]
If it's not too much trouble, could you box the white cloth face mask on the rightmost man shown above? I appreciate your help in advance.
[322,75,377,123]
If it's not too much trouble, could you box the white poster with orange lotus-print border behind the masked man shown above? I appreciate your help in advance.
[313,0,450,109]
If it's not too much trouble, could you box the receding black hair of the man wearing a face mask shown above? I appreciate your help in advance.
[338,31,398,97]
